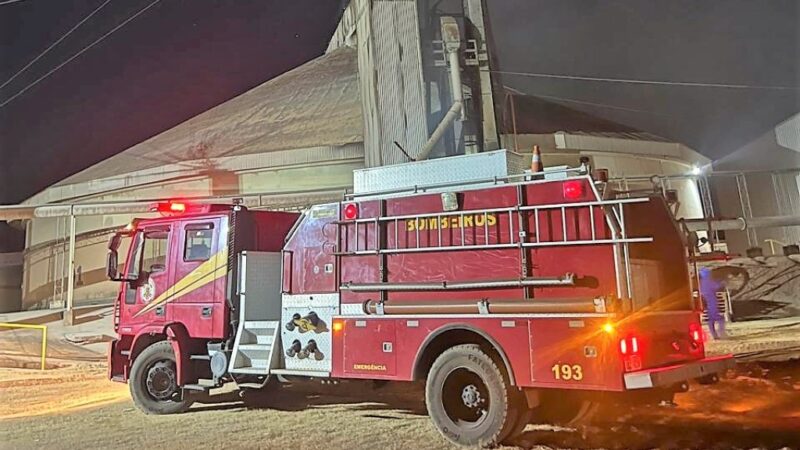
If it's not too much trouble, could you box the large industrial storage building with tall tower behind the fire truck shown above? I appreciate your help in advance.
[3,0,800,309]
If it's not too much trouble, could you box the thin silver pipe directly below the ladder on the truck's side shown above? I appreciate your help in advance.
[341,273,575,292]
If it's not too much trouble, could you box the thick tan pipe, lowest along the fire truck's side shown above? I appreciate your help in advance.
[364,299,606,314]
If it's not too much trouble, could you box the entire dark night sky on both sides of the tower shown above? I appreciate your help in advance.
[0,0,800,207]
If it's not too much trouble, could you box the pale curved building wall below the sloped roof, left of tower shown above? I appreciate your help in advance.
[17,148,364,309]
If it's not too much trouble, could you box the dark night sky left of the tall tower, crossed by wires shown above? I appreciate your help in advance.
[0,0,342,203]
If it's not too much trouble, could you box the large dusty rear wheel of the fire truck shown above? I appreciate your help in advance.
[425,344,522,447]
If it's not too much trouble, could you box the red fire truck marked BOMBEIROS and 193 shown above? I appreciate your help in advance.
[108,155,732,446]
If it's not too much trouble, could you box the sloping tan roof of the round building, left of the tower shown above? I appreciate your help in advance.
[57,48,364,185]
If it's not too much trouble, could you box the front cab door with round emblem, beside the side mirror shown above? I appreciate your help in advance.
[120,225,172,333]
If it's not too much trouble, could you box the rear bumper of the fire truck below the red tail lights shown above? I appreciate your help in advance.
[625,355,735,390]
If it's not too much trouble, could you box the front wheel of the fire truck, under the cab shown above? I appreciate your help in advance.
[128,341,194,414]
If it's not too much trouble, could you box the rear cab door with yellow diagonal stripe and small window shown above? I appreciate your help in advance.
[170,218,223,338]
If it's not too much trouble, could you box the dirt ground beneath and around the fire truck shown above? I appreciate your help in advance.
[0,361,800,449]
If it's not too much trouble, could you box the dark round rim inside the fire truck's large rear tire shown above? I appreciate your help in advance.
[442,367,491,428]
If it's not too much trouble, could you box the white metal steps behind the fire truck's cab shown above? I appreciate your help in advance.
[229,320,281,375]
